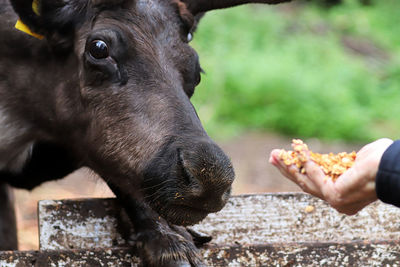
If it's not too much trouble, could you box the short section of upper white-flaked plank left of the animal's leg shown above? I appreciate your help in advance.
[38,198,126,250]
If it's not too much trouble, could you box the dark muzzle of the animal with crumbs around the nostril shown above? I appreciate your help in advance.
[143,139,235,225]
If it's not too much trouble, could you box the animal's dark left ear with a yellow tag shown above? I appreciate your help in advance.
[10,0,88,49]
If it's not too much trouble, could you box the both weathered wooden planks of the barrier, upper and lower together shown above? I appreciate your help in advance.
[0,193,400,266]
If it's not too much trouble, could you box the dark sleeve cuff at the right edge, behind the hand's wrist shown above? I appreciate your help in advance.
[376,140,400,207]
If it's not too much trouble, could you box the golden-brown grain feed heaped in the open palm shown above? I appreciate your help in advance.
[279,139,356,181]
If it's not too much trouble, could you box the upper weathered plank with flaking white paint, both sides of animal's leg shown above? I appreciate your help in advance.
[39,193,400,249]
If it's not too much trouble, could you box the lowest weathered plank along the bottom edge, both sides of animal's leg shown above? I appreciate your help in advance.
[0,241,400,267]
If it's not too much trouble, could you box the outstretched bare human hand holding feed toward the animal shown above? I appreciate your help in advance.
[269,138,393,215]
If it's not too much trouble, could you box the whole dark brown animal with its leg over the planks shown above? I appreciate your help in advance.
[0,0,285,266]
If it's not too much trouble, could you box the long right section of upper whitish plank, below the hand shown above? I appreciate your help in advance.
[193,193,400,245]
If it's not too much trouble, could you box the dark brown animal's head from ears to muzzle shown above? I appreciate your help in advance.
[11,0,290,225]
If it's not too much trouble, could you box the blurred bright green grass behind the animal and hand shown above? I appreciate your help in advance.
[192,0,400,142]
